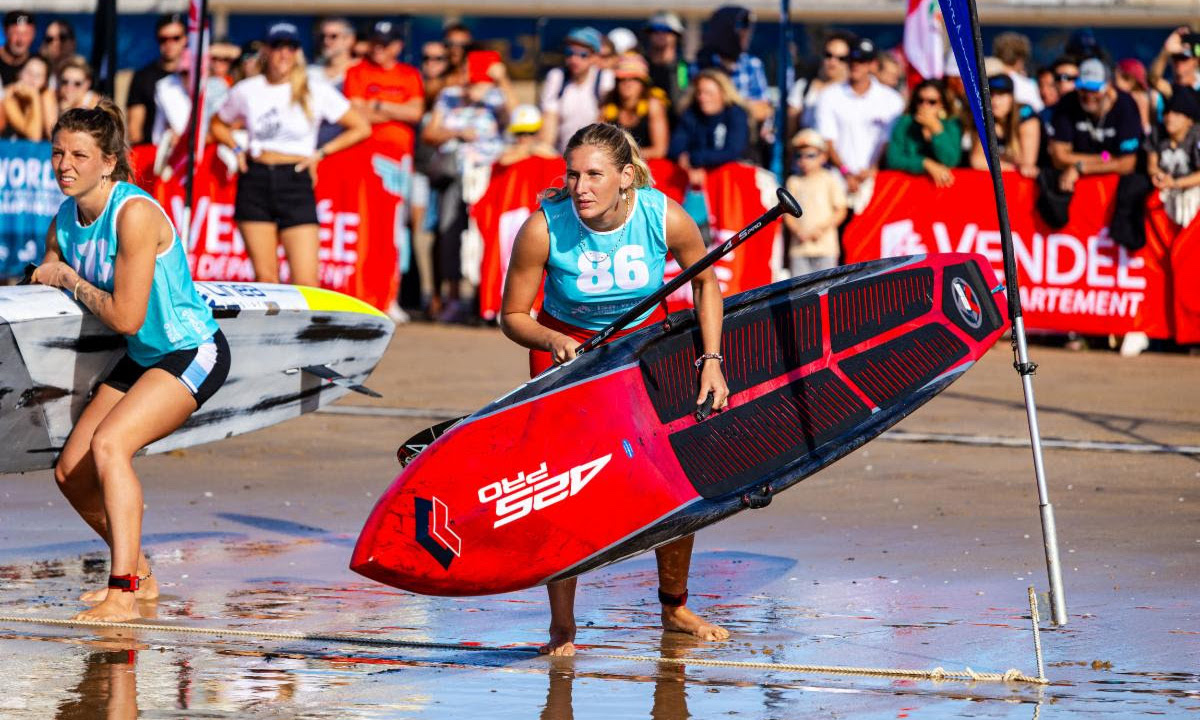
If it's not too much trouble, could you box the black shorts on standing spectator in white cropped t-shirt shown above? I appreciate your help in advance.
[233,162,317,230]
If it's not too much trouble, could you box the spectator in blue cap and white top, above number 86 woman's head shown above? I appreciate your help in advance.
[539,28,614,152]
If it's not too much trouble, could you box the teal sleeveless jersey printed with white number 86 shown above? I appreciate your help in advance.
[541,187,667,330]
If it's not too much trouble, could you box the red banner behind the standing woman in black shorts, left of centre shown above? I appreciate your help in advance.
[154,140,412,311]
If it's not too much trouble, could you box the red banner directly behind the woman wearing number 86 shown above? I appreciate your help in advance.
[472,157,782,319]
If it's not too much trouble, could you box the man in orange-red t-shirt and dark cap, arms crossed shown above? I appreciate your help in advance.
[344,20,425,156]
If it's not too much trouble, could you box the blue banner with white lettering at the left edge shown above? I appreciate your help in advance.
[0,140,65,278]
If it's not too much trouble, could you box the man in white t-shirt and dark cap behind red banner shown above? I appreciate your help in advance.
[816,38,904,212]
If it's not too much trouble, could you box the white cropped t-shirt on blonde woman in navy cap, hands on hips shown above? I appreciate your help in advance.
[217,68,350,157]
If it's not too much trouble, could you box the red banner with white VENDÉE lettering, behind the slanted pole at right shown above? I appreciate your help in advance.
[842,170,1177,338]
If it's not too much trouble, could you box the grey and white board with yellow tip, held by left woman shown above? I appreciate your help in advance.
[0,282,395,473]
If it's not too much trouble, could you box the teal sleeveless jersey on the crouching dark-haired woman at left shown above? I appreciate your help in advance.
[55,182,217,367]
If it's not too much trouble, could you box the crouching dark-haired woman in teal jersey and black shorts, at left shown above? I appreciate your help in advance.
[32,100,229,622]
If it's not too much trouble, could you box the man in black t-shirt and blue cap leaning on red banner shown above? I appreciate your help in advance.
[1046,58,1150,250]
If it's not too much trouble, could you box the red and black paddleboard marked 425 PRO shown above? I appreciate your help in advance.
[350,253,1008,595]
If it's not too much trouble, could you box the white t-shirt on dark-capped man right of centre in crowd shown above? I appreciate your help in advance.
[816,78,904,173]
